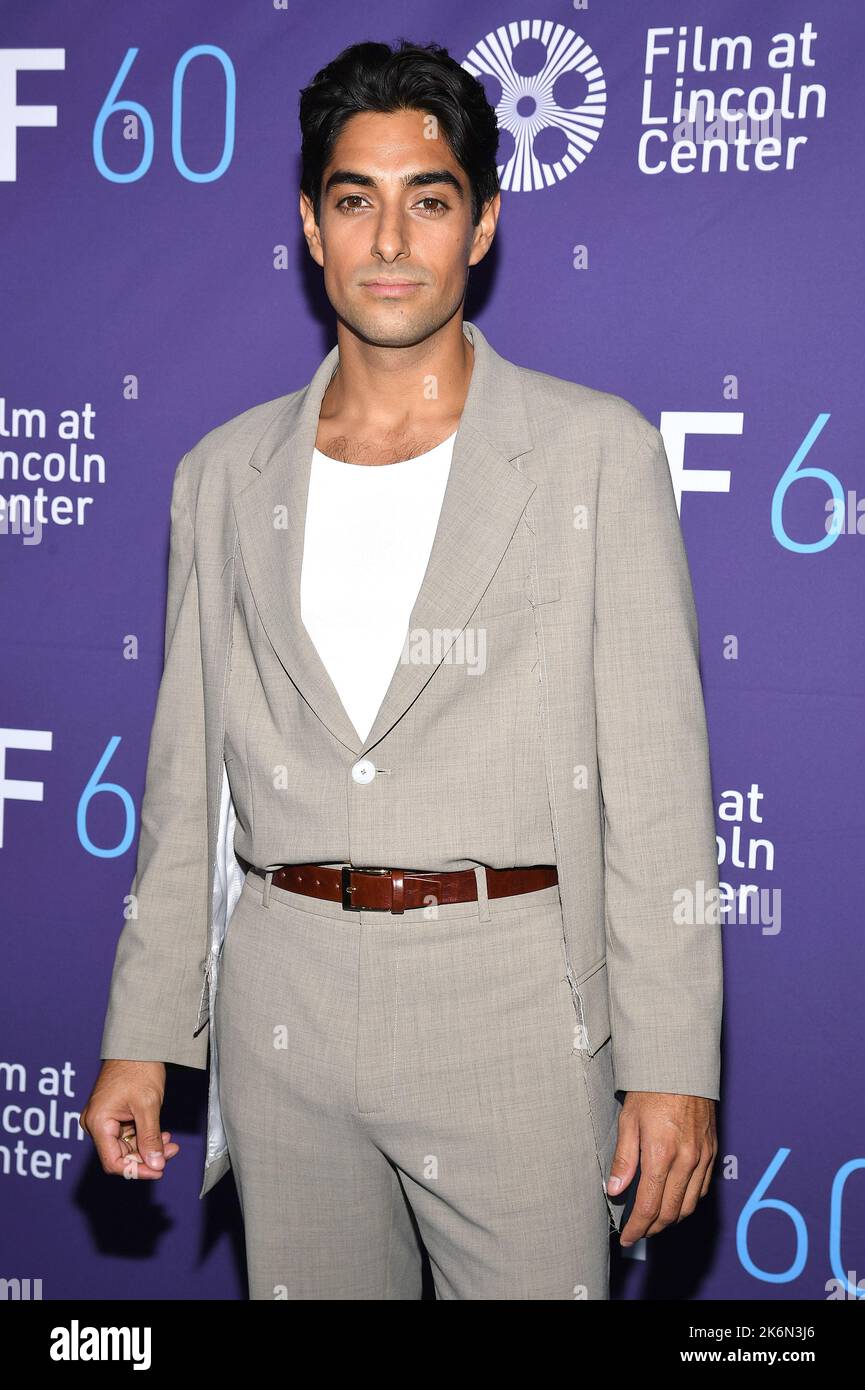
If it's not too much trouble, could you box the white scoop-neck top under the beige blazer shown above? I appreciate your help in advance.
[300,431,456,741]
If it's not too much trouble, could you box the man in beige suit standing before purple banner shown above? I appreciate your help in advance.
[82,43,722,1300]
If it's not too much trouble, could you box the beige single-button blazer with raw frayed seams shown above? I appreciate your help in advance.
[100,321,722,1195]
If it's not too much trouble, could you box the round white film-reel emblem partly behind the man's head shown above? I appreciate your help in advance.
[462,19,606,193]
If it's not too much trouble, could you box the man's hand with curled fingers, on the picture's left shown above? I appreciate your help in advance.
[78,1059,179,1177]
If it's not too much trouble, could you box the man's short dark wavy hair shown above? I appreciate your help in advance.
[300,39,499,227]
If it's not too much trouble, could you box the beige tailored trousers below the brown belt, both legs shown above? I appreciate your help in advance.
[211,869,615,1300]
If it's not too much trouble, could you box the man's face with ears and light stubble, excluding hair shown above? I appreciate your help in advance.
[300,111,501,348]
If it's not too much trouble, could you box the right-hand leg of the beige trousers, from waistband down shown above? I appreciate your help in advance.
[356,888,609,1300]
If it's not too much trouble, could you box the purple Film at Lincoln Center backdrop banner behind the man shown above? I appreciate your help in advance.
[0,0,865,1300]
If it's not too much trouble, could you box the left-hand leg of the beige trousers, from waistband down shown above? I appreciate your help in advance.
[214,880,421,1300]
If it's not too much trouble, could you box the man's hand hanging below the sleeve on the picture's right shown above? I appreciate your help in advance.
[606,1091,718,1245]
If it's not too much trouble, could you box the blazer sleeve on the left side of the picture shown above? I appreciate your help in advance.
[100,455,209,1070]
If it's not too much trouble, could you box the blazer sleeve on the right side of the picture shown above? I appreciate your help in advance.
[594,420,723,1099]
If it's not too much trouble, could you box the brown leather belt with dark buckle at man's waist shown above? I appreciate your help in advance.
[249,865,559,912]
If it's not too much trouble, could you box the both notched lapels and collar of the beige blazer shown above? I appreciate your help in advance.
[234,320,535,756]
